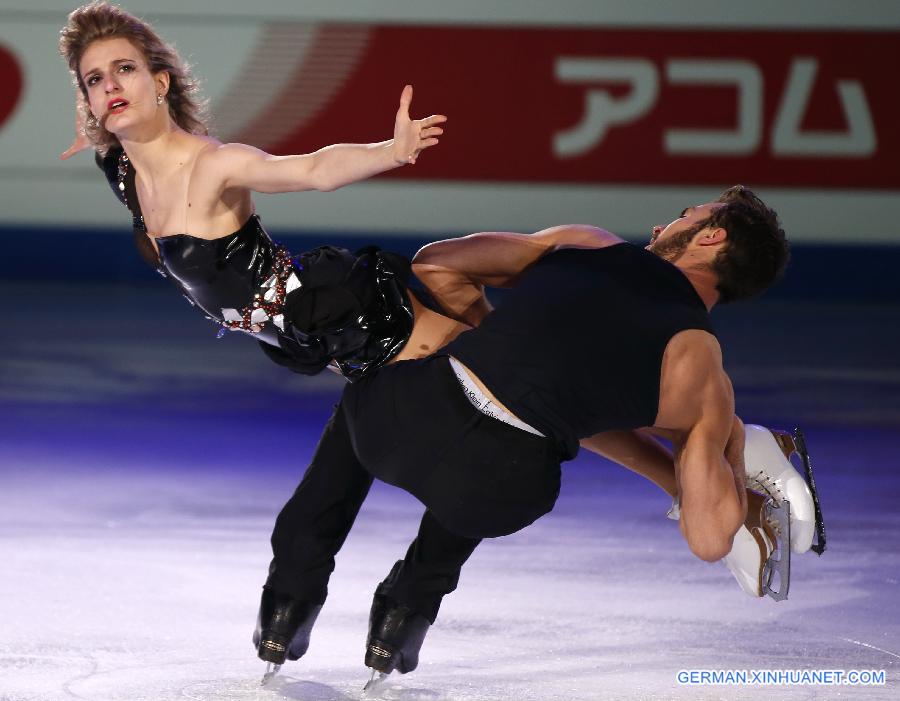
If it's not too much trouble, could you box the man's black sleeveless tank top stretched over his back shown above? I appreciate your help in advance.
[444,243,712,458]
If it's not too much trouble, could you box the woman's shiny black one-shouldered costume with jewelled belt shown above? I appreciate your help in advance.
[97,148,413,381]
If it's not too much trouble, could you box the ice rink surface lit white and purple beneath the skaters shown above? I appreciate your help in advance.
[0,282,900,701]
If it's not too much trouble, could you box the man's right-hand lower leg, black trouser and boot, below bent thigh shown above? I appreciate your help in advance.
[365,511,481,674]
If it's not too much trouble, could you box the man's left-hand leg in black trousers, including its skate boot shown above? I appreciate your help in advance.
[253,396,372,664]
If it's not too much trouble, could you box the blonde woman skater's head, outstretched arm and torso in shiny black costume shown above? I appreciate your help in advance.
[59,2,446,377]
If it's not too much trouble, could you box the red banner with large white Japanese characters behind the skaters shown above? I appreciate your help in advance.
[256,25,900,189]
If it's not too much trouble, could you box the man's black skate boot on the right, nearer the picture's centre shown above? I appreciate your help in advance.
[366,593,431,674]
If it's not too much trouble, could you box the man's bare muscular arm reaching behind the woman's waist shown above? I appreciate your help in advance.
[413,225,622,326]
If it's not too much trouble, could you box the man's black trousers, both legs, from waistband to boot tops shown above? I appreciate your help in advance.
[267,357,559,622]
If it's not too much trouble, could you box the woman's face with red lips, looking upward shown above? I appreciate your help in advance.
[79,38,168,134]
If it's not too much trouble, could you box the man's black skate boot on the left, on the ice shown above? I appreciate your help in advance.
[253,587,322,665]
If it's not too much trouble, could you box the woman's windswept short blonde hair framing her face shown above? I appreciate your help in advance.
[59,0,208,154]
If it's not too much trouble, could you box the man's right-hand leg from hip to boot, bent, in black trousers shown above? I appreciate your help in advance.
[344,356,560,673]
